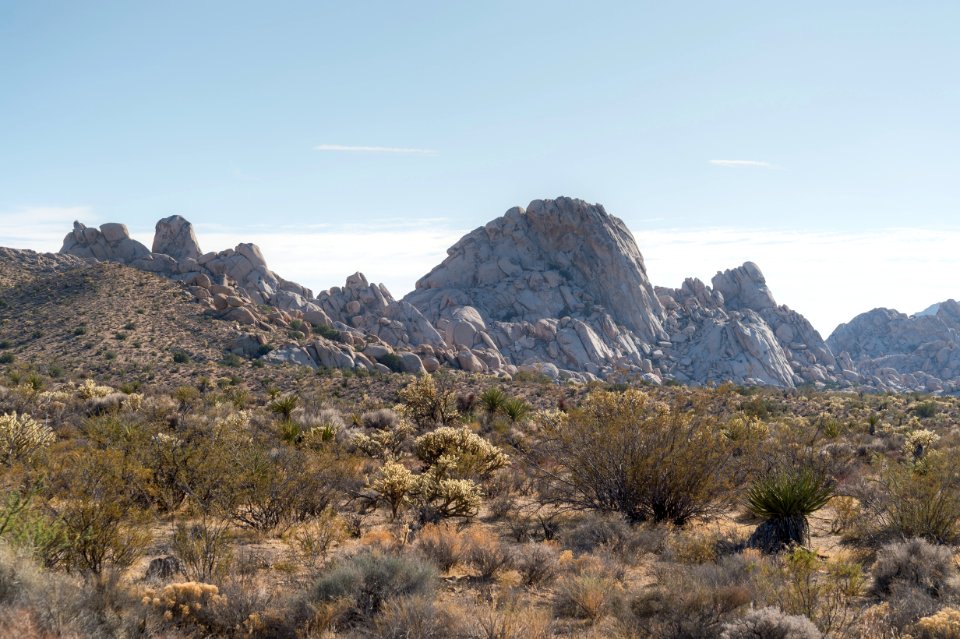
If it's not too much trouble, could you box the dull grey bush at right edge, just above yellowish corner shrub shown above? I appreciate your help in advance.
[873,539,956,597]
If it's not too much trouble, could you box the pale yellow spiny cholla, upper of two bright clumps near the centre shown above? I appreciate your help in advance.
[414,426,508,478]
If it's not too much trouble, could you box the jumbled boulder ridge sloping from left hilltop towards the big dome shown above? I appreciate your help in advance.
[60,215,456,373]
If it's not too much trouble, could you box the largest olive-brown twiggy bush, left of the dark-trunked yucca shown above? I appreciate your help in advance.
[521,390,733,525]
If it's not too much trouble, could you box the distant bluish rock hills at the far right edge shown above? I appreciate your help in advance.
[827,300,960,393]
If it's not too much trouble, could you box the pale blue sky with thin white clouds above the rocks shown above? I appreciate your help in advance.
[0,0,960,336]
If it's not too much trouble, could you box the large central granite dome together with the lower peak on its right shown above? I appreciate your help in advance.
[405,198,849,387]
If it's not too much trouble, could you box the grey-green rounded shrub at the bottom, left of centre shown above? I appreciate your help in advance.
[312,552,436,619]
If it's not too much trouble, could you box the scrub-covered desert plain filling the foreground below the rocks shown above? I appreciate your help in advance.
[0,358,960,639]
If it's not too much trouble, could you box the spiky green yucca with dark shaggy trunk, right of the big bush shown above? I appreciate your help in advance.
[747,468,833,553]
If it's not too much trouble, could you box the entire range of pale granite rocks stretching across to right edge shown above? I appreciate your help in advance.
[60,198,960,392]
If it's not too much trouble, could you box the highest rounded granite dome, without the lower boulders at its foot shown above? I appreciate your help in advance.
[407,197,663,340]
